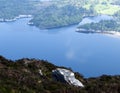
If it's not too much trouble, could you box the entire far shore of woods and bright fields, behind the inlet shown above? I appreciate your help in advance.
[0,0,120,29]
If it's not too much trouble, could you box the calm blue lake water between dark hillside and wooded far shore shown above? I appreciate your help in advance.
[0,19,120,77]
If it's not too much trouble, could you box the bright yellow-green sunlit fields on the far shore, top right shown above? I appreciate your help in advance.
[83,0,120,15]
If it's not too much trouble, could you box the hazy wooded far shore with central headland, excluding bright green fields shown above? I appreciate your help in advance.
[0,0,89,28]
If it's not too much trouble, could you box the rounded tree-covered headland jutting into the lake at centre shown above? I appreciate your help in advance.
[31,5,88,28]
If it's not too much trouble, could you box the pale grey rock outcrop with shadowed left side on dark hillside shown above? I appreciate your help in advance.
[52,68,84,87]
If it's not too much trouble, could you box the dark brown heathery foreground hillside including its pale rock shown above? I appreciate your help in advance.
[0,56,120,93]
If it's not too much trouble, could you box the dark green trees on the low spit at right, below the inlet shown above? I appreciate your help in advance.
[78,20,120,31]
